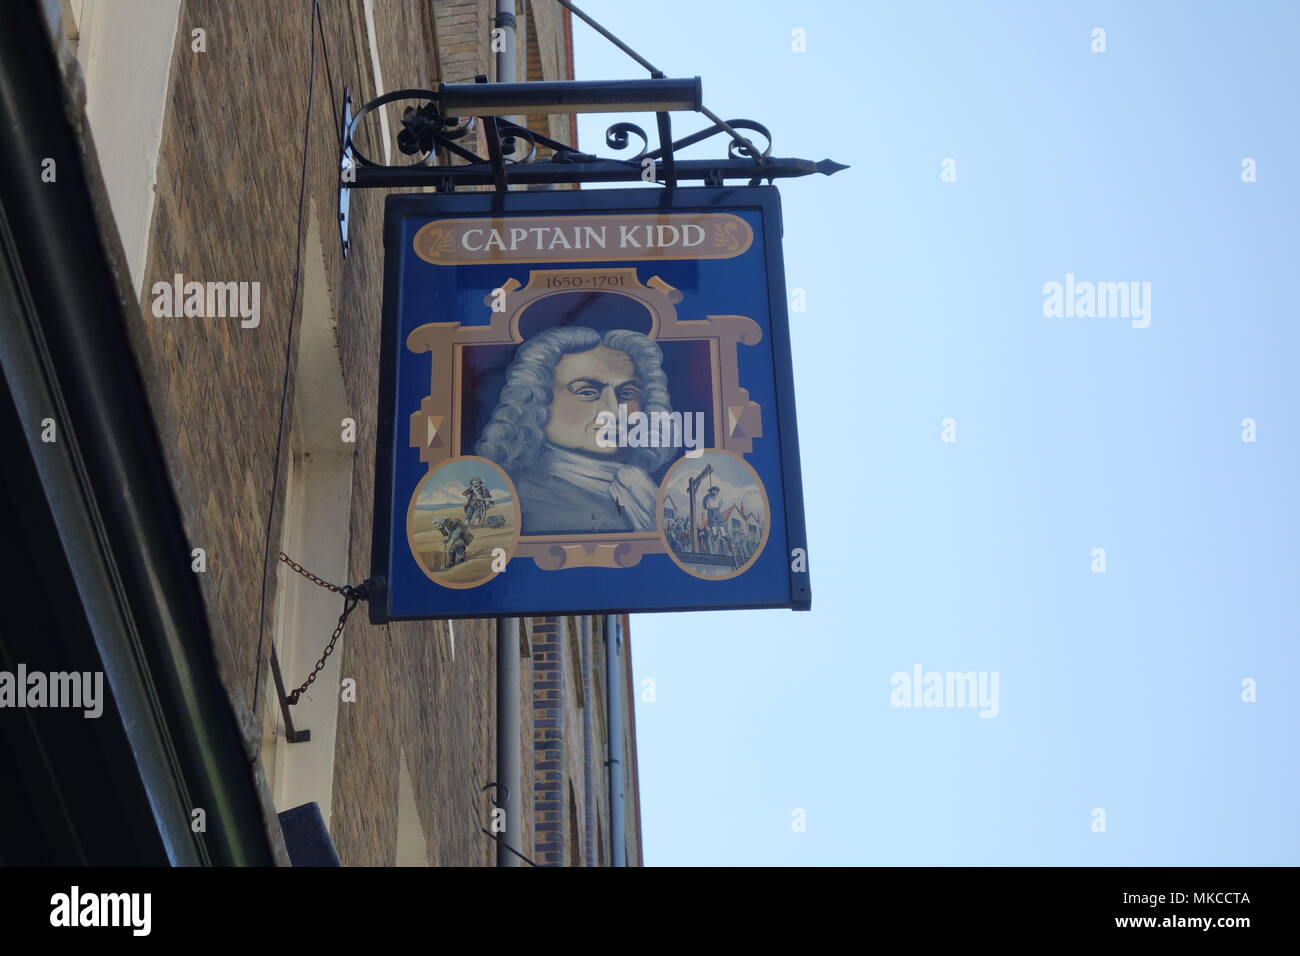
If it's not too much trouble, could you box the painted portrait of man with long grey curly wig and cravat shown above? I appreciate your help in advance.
[475,325,675,535]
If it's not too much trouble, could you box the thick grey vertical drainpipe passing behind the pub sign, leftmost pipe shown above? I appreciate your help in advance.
[493,0,529,866]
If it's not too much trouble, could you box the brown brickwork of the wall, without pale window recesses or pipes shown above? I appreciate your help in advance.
[130,0,631,865]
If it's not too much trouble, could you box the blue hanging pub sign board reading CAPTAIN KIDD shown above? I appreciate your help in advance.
[369,186,811,623]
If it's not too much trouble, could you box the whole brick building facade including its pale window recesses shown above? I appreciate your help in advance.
[55,0,641,865]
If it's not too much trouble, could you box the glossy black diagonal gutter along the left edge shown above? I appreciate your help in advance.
[0,0,274,865]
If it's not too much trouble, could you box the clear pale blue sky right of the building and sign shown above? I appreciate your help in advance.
[575,0,1300,865]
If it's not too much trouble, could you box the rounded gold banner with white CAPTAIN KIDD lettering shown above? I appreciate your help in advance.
[412,212,754,265]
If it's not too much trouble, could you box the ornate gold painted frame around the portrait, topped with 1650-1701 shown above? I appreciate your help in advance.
[406,267,763,571]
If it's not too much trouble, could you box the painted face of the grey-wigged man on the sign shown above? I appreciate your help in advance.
[546,345,641,455]
